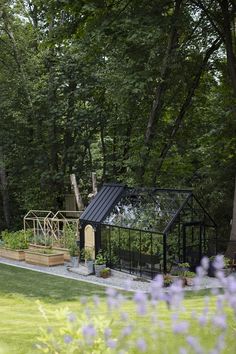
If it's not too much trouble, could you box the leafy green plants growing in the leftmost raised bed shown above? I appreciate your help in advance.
[2,230,32,250]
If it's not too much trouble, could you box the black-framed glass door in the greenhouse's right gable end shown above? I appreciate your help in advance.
[183,222,204,268]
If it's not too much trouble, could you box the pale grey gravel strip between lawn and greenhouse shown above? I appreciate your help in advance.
[0,257,230,292]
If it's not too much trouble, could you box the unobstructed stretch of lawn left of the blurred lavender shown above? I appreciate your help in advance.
[0,264,104,354]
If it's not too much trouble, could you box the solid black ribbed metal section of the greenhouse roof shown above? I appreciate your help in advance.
[80,184,125,224]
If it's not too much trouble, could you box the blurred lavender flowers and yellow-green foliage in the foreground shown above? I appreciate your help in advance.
[36,256,236,354]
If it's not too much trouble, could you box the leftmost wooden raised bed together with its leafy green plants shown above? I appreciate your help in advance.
[0,230,32,261]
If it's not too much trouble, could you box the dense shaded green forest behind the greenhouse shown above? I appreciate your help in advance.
[0,0,236,245]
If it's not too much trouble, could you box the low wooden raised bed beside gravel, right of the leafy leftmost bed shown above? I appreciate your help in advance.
[25,250,64,267]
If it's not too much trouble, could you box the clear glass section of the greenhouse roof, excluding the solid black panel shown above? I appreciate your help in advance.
[102,187,192,234]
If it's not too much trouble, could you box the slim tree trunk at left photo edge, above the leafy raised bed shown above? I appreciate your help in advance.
[0,147,10,229]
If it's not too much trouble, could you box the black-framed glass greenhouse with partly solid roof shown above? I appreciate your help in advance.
[80,184,217,278]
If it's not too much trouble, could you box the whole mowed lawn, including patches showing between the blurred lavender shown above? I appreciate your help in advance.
[0,264,236,354]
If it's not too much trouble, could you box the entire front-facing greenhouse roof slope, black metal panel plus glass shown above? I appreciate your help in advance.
[80,184,203,234]
